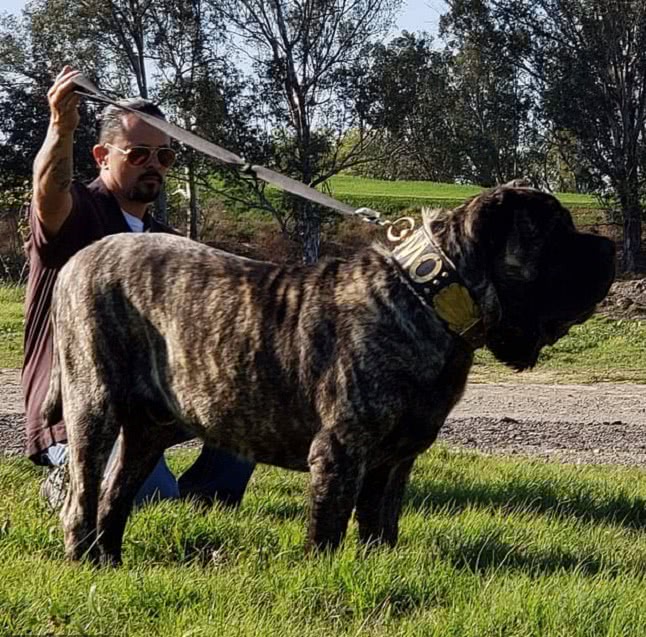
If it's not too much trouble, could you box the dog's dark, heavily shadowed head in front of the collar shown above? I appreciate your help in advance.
[463,184,615,370]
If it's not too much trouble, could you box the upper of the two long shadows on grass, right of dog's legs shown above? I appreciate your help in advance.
[405,478,646,529]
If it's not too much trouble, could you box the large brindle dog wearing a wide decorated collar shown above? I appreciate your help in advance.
[44,186,614,563]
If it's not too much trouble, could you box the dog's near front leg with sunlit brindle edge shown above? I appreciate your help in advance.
[306,430,365,551]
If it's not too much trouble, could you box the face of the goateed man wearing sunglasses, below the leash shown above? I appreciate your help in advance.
[95,113,170,203]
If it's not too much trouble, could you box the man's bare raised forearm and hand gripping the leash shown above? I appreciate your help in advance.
[32,66,79,237]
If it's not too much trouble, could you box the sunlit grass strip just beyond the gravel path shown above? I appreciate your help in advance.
[0,286,646,383]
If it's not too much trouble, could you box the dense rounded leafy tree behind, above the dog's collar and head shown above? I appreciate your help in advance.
[350,26,543,186]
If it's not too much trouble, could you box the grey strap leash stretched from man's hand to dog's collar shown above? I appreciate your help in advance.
[72,75,388,229]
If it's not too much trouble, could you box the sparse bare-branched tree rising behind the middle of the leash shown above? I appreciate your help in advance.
[211,0,401,263]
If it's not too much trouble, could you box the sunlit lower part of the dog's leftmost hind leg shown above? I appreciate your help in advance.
[61,396,119,563]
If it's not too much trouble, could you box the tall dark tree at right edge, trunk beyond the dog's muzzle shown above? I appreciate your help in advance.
[541,0,646,272]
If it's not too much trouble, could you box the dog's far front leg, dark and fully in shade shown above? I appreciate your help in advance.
[356,458,415,546]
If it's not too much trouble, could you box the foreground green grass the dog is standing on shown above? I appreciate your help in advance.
[0,449,646,637]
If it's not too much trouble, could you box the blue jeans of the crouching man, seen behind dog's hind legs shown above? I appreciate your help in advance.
[43,443,255,506]
